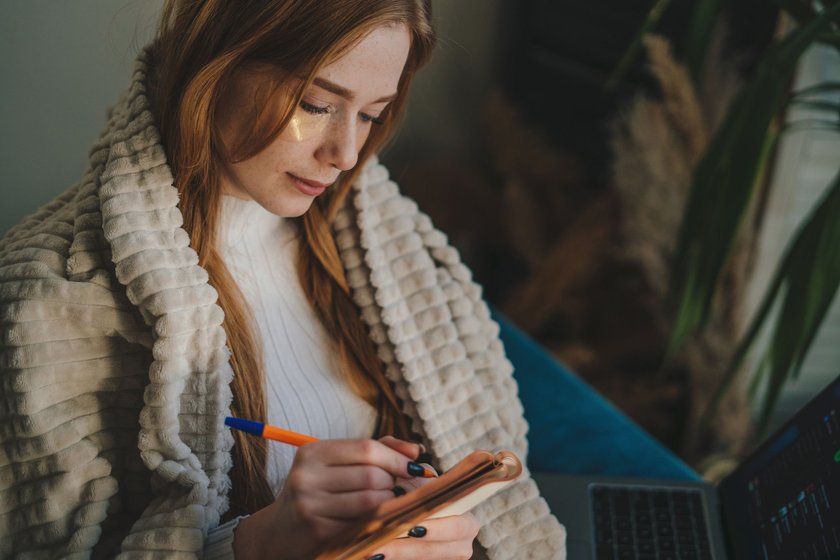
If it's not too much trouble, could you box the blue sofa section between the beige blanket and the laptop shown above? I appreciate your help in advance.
[494,311,699,480]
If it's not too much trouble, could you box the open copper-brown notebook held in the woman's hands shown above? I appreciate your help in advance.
[318,451,522,560]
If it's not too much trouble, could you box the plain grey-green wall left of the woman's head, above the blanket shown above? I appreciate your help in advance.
[0,0,162,235]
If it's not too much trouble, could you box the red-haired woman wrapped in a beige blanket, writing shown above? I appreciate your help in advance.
[0,0,564,559]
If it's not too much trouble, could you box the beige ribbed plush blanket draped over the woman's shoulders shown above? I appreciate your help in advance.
[0,51,565,559]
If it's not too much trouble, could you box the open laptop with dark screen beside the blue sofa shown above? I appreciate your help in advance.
[533,377,840,560]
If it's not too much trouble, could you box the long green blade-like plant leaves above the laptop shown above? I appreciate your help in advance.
[656,0,840,438]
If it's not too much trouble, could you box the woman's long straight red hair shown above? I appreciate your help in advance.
[150,0,435,515]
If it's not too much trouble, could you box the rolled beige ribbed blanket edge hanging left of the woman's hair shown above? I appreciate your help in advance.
[91,53,233,529]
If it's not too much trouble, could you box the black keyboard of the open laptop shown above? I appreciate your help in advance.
[590,485,712,560]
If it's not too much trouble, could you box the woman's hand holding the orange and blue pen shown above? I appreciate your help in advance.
[234,437,422,559]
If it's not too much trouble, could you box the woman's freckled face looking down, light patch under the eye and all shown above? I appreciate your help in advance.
[218,25,410,217]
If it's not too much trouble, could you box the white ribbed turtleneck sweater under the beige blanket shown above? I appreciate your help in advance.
[219,196,376,495]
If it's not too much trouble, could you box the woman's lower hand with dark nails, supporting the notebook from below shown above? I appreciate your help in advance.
[371,513,481,560]
